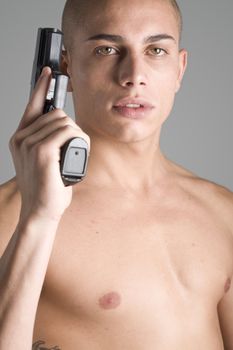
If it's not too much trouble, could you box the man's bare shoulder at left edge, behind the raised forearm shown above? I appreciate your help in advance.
[0,178,21,256]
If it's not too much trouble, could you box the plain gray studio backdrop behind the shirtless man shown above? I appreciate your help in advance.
[0,0,233,190]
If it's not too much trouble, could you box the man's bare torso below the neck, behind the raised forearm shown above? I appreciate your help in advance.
[1,163,233,350]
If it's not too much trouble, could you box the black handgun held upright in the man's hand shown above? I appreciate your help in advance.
[31,28,89,186]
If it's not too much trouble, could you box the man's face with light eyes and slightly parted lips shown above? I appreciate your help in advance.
[64,0,186,142]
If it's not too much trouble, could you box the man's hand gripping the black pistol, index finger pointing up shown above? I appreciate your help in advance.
[9,67,90,221]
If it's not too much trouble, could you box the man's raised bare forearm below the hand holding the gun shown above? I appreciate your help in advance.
[0,219,58,350]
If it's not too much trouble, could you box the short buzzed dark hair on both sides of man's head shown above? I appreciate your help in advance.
[62,0,183,50]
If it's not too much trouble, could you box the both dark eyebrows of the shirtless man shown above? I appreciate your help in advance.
[85,33,176,44]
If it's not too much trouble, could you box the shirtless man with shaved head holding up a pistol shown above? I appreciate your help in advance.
[0,0,233,350]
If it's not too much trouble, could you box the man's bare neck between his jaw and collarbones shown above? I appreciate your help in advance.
[76,132,173,191]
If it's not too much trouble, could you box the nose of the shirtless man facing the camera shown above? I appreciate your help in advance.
[118,54,147,88]
